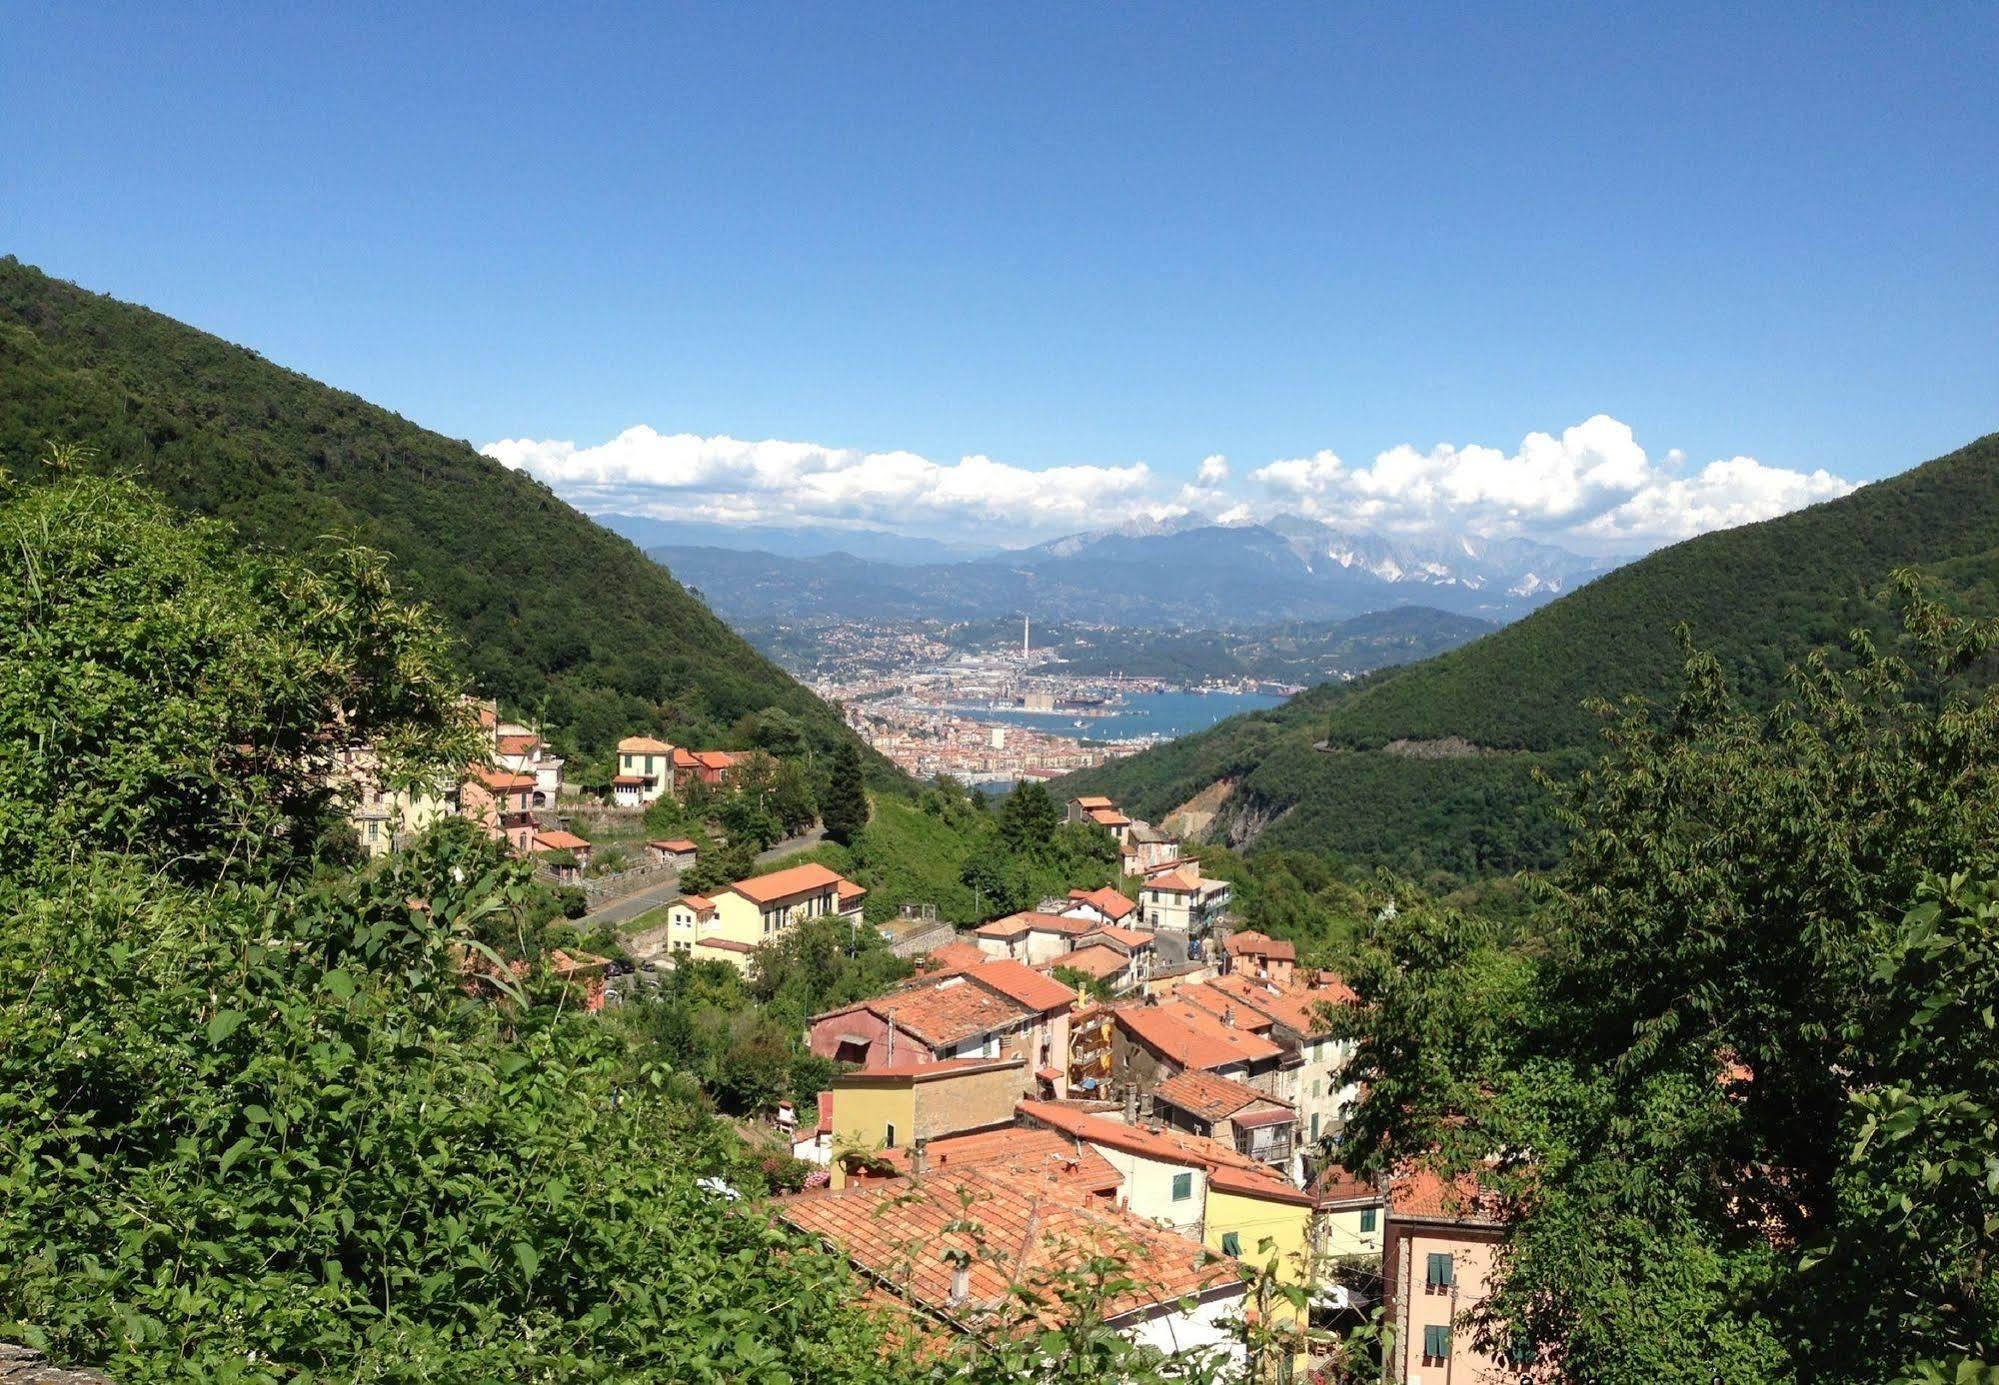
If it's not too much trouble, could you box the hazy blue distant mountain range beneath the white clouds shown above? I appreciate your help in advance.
[648,516,1617,630]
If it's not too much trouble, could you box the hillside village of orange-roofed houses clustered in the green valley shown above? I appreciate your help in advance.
[348,703,1515,1381]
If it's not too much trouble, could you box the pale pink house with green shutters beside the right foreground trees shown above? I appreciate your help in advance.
[1381,1169,1519,1385]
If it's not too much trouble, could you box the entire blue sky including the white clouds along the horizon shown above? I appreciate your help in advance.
[0,4,1999,544]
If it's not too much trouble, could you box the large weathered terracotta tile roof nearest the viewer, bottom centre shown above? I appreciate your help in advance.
[774,1169,1243,1323]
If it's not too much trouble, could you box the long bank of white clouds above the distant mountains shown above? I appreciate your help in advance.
[482,414,1853,552]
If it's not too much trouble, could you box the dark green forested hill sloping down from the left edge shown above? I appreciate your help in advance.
[0,256,894,781]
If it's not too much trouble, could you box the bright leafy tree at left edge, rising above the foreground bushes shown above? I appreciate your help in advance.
[0,472,474,873]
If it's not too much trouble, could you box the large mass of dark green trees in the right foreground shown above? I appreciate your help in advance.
[1349,595,1999,1381]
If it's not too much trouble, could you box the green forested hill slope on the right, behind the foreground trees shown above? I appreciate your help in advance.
[1061,434,1999,877]
